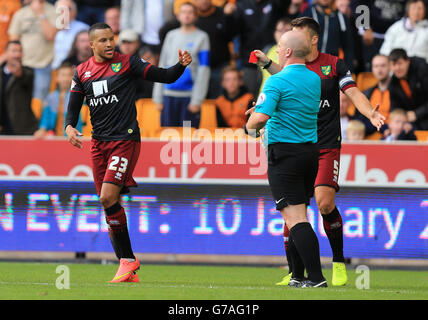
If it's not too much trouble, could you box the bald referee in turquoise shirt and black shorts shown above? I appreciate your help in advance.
[245,30,327,287]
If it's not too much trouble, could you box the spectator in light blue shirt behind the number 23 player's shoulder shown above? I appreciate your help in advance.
[52,0,89,69]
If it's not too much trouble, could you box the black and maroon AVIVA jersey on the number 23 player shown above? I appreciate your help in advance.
[65,52,185,141]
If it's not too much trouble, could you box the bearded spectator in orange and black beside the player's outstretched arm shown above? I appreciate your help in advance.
[355,54,391,136]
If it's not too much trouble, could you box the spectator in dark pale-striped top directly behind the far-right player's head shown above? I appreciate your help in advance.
[302,0,355,71]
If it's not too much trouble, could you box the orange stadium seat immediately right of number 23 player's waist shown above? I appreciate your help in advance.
[135,99,161,138]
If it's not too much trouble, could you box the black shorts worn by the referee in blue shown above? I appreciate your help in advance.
[268,143,319,210]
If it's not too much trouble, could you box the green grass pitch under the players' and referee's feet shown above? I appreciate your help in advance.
[0,263,428,300]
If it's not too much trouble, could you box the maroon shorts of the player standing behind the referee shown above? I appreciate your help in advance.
[315,149,340,192]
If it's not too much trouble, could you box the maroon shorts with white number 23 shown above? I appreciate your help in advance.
[91,139,141,195]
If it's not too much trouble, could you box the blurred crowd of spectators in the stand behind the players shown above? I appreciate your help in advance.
[0,0,428,141]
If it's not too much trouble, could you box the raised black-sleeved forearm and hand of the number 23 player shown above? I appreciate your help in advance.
[146,50,192,83]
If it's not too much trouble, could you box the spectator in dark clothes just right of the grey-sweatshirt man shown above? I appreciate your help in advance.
[195,0,233,99]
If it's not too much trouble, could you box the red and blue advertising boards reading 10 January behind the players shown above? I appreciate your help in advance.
[0,137,428,266]
